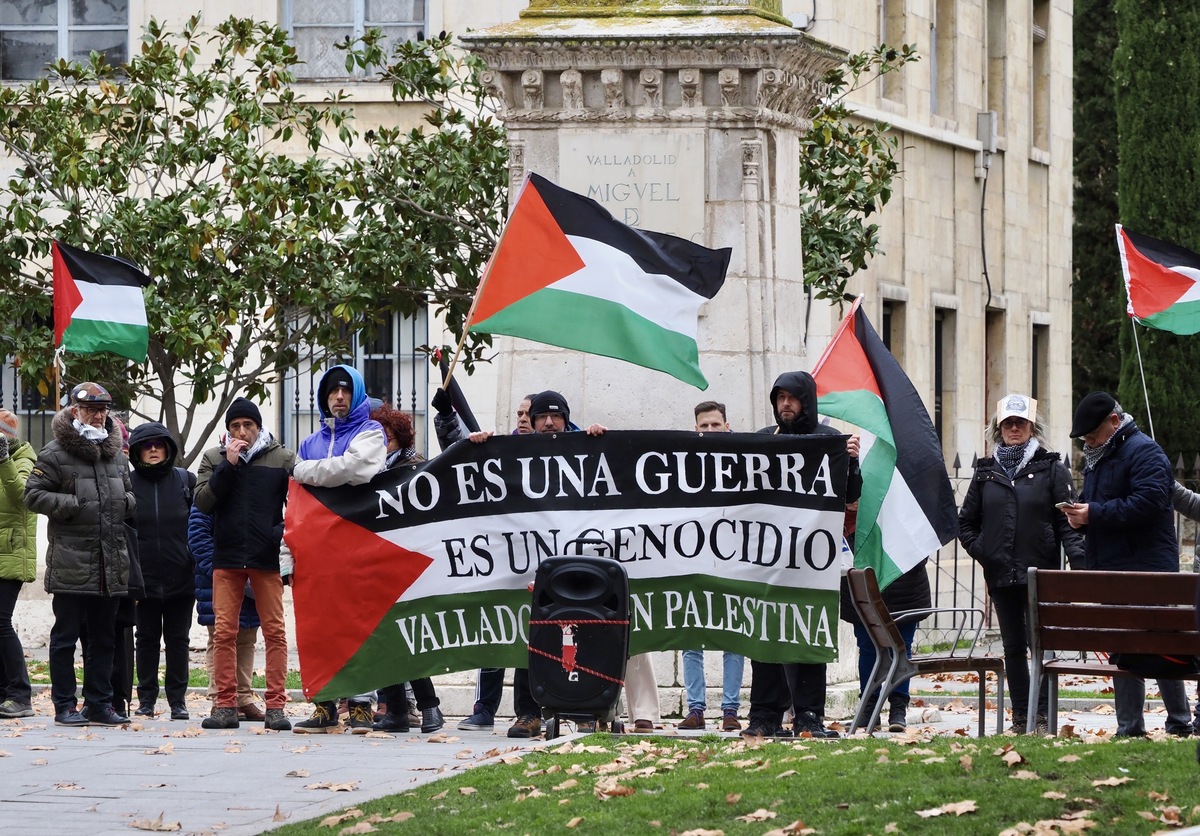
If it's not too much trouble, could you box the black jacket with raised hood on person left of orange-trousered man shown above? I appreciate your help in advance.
[130,421,196,600]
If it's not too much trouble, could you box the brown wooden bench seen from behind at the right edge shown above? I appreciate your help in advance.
[1027,569,1200,734]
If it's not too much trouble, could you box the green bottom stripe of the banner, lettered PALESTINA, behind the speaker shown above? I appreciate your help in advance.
[314,575,839,699]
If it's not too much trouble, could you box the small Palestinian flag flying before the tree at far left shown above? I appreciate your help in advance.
[50,241,150,362]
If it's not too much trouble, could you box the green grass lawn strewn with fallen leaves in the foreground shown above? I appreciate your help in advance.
[272,734,1200,836]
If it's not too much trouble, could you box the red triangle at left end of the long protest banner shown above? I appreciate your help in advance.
[287,482,433,698]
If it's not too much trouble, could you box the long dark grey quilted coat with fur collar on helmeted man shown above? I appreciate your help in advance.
[25,407,137,596]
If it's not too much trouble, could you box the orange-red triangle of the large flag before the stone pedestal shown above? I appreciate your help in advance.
[467,176,584,327]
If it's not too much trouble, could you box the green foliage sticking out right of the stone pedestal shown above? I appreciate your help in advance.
[800,44,919,300]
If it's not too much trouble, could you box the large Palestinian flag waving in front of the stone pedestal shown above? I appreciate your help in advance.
[467,174,730,389]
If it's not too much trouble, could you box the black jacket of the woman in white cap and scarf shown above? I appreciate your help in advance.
[959,446,1084,589]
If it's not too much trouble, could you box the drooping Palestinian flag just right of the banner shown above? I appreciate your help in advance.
[812,299,959,589]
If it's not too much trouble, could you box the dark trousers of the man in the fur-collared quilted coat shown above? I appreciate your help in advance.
[49,593,119,712]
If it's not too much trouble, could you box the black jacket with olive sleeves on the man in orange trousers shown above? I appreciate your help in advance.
[196,429,296,572]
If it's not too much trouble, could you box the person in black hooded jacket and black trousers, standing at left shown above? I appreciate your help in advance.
[130,421,196,720]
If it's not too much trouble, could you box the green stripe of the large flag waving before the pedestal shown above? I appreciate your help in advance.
[470,289,708,389]
